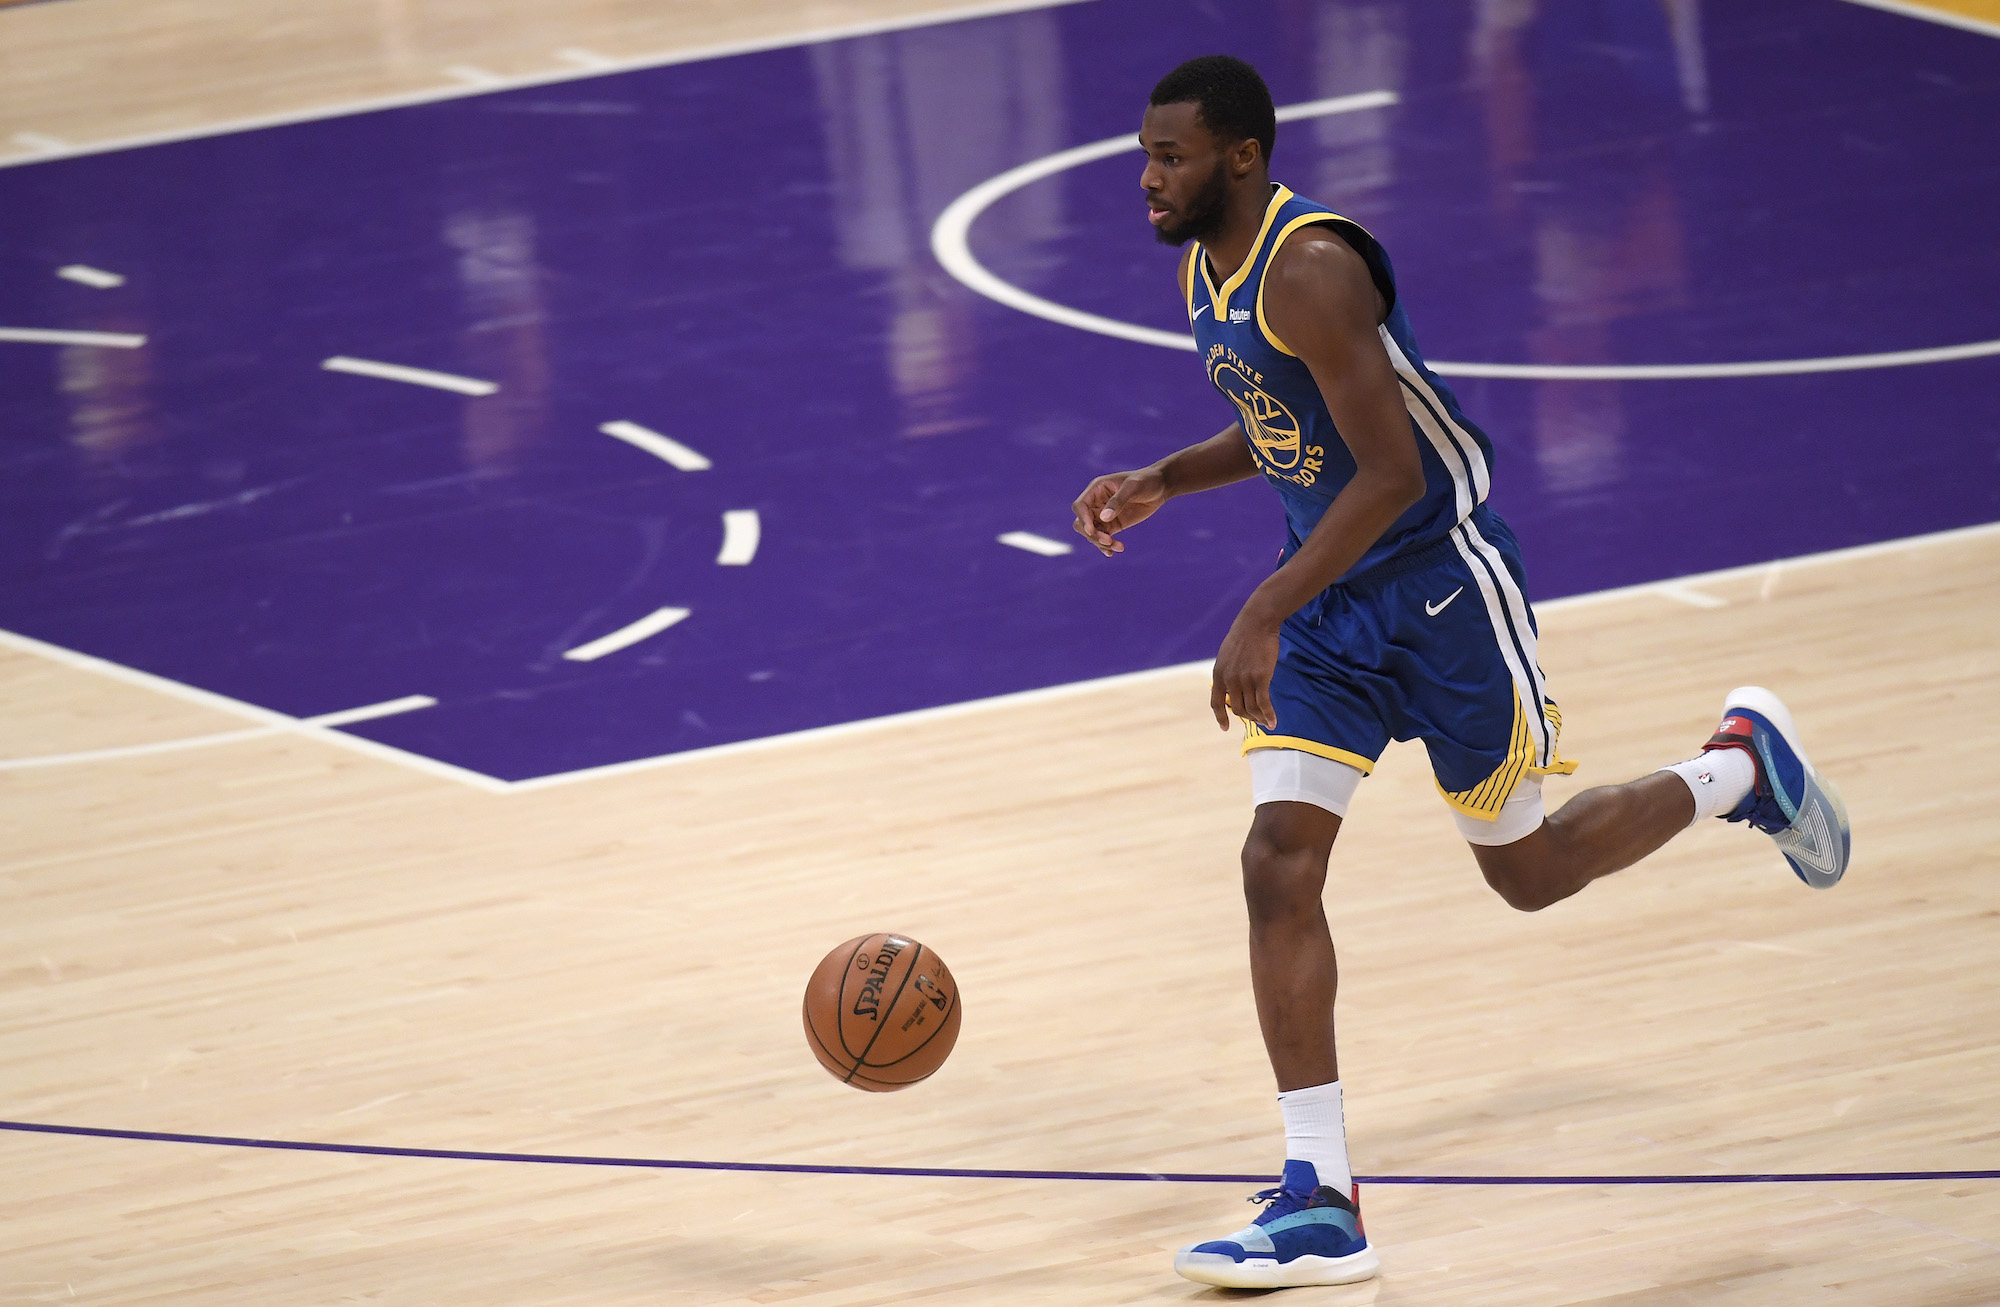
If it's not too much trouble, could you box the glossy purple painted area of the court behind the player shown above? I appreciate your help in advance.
[0,0,2000,779]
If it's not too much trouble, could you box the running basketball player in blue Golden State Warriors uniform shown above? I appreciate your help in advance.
[1074,56,1850,1289]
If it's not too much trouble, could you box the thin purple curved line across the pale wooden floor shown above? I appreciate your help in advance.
[0,1121,2000,1185]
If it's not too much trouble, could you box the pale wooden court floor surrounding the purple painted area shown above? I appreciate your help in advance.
[0,0,2000,1307]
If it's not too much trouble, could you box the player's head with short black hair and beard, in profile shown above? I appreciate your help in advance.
[1138,54,1278,246]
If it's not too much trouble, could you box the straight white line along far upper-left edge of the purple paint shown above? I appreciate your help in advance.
[0,0,1088,168]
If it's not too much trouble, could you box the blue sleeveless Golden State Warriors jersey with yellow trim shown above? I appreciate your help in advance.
[1186,186,1492,582]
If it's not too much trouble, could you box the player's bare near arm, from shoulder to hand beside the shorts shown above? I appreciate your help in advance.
[1210,230,1424,729]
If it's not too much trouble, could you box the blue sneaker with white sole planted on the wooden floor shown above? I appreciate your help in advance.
[1174,1161,1382,1289]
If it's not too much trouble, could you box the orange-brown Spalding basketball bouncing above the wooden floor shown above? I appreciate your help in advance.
[806,935,958,1093]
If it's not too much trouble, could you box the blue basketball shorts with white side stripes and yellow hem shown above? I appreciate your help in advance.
[1244,506,1576,821]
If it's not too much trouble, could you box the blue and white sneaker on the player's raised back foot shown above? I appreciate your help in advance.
[1702,685,1854,889]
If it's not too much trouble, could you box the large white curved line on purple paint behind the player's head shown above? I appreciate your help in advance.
[930,90,2000,382]
